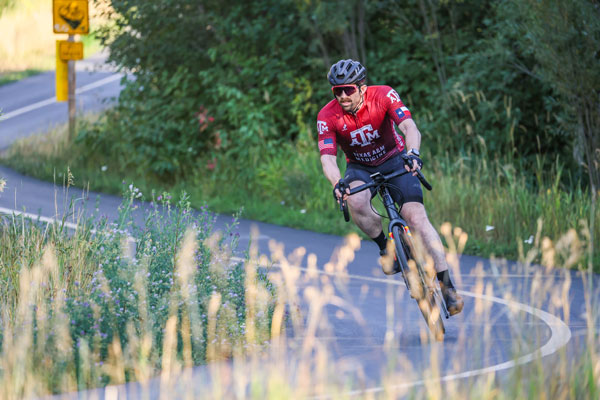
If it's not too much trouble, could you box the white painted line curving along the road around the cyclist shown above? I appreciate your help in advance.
[0,207,571,399]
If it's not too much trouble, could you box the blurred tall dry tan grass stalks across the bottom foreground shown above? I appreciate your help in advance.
[0,190,600,399]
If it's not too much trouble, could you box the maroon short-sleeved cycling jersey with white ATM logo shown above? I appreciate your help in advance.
[317,86,411,166]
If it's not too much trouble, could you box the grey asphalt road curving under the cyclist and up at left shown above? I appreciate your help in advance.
[0,55,598,397]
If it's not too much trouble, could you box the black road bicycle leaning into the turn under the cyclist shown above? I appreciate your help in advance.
[340,155,450,341]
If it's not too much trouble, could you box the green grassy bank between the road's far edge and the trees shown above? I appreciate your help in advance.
[2,116,600,272]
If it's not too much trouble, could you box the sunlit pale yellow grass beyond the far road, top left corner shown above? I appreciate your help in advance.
[0,0,100,85]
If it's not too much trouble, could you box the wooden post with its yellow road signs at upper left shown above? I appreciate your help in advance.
[52,0,90,140]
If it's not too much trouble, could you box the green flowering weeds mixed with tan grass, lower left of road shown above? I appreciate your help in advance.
[0,185,275,399]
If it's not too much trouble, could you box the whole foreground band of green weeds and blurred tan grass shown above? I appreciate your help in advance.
[0,195,600,399]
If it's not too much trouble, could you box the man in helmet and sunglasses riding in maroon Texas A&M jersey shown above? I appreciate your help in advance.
[317,60,464,315]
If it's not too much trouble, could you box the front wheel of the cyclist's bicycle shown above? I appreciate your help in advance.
[392,226,446,342]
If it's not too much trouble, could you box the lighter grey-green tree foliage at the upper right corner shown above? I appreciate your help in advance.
[509,0,600,197]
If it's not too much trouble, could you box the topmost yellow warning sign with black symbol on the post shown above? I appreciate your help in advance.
[52,0,90,35]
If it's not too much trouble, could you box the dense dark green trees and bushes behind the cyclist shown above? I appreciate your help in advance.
[79,0,592,193]
